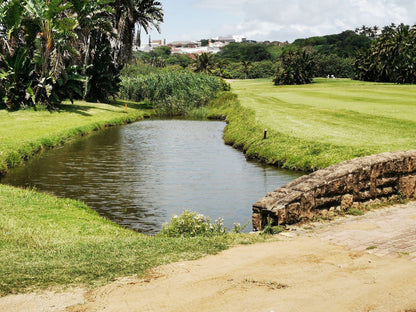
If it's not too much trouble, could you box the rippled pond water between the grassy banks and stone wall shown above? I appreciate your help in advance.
[1,120,303,234]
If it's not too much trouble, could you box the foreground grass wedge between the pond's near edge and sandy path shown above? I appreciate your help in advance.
[0,185,262,295]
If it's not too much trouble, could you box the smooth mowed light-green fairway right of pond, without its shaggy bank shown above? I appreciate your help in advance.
[231,78,416,158]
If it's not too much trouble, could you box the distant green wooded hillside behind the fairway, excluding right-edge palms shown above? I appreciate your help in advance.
[127,27,376,79]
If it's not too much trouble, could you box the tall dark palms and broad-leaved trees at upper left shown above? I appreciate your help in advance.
[0,0,163,110]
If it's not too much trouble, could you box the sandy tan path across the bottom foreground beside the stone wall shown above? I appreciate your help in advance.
[0,203,416,312]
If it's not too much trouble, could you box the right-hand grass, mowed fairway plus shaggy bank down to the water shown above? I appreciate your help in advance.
[224,79,416,170]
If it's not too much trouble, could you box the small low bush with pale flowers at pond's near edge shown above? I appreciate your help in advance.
[159,210,227,237]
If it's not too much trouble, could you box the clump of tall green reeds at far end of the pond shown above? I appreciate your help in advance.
[120,71,229,116]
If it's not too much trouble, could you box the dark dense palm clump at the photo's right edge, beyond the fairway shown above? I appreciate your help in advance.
[355,24,416,83]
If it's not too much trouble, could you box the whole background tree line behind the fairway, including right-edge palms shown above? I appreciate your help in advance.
[139,24,416,84]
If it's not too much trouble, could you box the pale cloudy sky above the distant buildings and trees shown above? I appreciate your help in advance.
[142,0,416,42]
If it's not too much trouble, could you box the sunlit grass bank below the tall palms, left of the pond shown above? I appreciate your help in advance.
[0,101,151,174]
